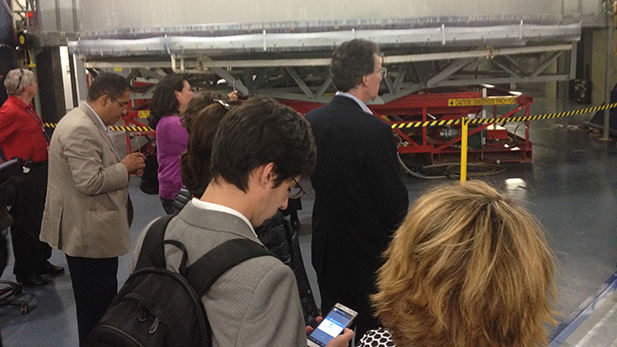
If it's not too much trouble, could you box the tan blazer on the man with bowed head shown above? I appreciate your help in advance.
[40,103,131,258]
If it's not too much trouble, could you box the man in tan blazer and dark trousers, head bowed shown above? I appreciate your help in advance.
[41,73,145,346]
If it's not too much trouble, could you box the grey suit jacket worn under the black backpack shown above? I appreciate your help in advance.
[131,202,306,347]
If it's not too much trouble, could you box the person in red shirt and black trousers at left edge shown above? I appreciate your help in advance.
[0,69,64,286]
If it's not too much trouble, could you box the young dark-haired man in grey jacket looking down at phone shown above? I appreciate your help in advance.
[133,97,353,347]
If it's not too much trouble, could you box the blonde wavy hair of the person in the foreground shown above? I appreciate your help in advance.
[372,181,556,347]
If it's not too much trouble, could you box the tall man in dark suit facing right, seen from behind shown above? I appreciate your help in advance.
[306,39,409,338]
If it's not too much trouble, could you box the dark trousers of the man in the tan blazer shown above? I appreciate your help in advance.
[66,255,118,347]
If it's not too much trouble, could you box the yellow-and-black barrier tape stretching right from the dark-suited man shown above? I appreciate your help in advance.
[392,103,617,129]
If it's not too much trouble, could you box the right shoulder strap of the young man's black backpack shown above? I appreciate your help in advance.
[187,239,274,297]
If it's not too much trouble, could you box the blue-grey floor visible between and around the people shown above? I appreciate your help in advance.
[0,99,617,347]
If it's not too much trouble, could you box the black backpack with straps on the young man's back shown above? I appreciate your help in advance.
[89,215,272,347]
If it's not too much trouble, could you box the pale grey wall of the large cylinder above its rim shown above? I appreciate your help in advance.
[71,0,599,33]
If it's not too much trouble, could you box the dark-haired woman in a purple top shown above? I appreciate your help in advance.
[149,74,193,213]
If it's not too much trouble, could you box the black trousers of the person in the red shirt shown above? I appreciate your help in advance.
[10,162,51,276]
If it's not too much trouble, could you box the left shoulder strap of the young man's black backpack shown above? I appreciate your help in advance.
[135,214,176,270]
